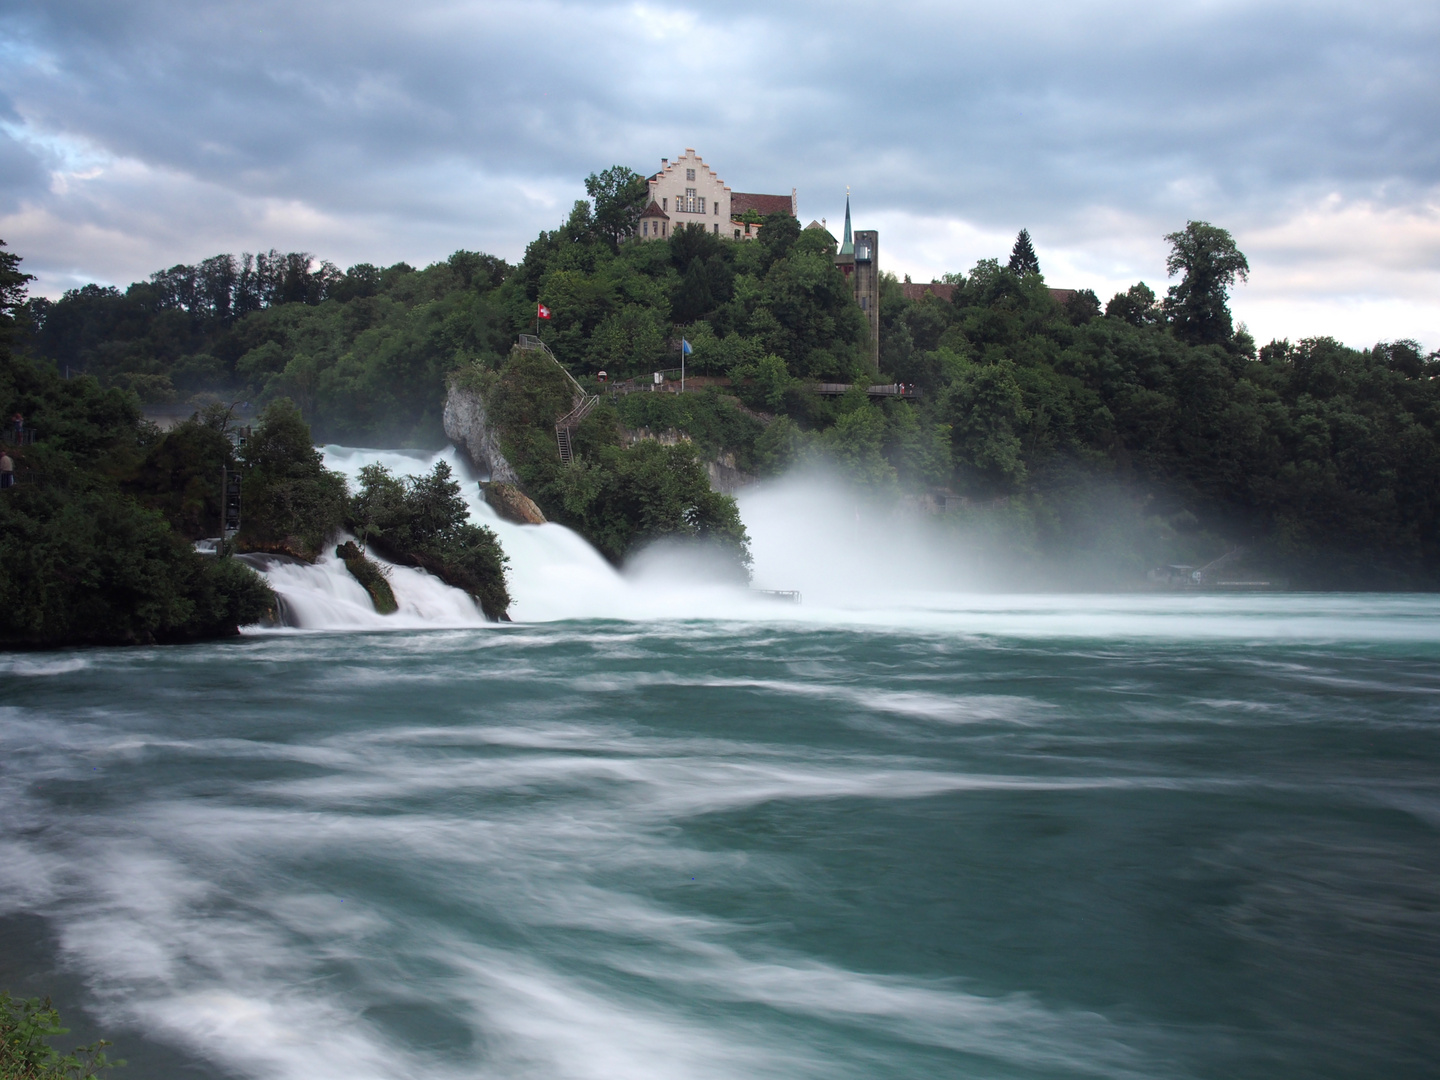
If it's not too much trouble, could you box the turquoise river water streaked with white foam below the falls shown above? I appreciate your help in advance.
[0,596,1440,1080]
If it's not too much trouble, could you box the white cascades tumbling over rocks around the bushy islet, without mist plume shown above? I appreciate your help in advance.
[244,445,776,629]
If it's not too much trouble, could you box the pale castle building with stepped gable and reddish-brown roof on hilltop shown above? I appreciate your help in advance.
[639,148,799,240]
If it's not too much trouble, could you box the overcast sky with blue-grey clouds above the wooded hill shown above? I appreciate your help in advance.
[0,0,1440,348]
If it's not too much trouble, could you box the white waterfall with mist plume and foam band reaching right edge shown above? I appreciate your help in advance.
[221,446,1440,642]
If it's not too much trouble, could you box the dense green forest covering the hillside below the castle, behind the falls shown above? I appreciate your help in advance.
[16,167,1440,588]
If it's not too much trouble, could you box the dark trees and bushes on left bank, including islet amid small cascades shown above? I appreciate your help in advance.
[0,241,510,648]
